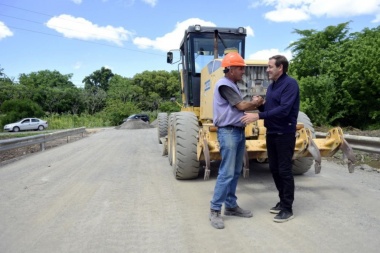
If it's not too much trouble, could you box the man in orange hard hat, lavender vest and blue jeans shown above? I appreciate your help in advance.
[209,52,263,229]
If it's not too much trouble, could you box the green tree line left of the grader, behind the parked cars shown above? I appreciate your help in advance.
[0,67,180,125]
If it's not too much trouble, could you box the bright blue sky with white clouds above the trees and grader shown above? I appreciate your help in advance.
[0,0,380,87]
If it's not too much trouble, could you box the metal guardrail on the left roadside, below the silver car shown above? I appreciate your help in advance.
[0,127,86,152]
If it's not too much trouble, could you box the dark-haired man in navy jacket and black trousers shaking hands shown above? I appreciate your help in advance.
[241,55,300,222]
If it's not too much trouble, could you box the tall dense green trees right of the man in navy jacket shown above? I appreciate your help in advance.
[289,22,380,128]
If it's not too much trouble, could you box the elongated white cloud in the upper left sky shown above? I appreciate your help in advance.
[46,14,133,46]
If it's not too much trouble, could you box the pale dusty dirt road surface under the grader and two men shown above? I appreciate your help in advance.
[0,128,380,253]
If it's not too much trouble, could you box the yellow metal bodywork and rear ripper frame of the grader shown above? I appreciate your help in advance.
[174,59,355,179]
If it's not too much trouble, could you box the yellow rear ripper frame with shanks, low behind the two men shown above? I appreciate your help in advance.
[197,120,355,177]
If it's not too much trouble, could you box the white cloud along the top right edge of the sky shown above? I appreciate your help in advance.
[255,0,380,23]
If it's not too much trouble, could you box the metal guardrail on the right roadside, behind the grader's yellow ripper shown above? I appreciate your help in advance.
[315,132,380,154]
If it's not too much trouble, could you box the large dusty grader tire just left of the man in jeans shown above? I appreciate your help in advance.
[170,112,199,180]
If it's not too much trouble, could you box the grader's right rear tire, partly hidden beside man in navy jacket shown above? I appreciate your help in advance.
[292,112,315,175]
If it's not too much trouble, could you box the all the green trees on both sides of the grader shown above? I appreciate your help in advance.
[0,22,380,130]
